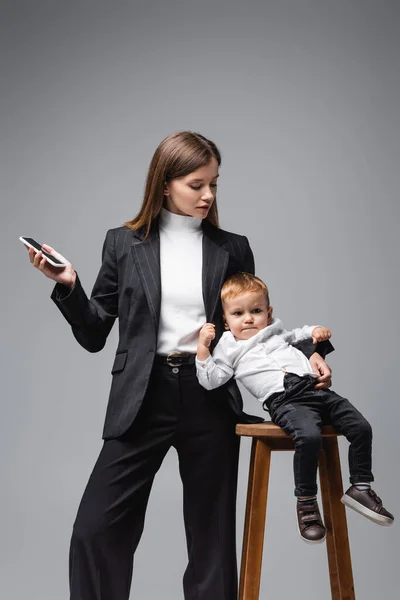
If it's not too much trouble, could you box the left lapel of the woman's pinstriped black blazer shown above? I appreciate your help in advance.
[131,225,161,334]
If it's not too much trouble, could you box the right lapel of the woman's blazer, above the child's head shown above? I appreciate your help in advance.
[202,222,229,323]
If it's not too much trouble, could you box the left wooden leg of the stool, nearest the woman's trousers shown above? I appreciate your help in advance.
[239,438,271,600]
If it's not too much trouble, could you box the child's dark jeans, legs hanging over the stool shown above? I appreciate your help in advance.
[264,373,374,496]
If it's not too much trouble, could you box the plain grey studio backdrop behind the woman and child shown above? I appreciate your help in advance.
[0,0,400,600]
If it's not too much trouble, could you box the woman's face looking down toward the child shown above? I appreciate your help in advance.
[164,158,218,219]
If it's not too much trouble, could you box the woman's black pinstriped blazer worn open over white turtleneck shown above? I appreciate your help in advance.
[51,219,332,438]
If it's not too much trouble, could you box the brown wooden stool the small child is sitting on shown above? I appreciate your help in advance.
[236,423,355,600]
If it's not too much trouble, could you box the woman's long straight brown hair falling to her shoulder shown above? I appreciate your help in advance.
[124,131,221,237]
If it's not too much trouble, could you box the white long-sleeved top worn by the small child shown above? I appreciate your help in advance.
[196,319,318,402]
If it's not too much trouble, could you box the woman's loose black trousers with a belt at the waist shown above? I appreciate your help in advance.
[70,365,239,600]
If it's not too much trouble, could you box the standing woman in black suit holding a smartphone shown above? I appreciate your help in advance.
[29,131,330,600]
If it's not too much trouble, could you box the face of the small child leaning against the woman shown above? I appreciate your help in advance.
[223,292,272,340]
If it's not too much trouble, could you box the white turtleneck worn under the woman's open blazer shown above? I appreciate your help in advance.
[157,208,206,355]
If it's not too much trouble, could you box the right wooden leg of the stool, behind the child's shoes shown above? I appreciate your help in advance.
[319,438,355,600]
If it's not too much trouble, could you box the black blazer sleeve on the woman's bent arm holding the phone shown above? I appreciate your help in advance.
[51,229,118,352]
